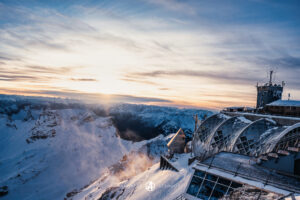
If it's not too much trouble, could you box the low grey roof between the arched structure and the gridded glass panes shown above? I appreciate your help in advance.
[195,152,300,194]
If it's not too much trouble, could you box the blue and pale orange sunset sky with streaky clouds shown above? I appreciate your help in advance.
[0,0,300,109]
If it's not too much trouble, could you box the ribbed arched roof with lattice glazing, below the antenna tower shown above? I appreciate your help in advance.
[192,114,300,159]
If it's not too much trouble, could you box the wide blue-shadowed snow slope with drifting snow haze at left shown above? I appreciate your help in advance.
[0,109,162,200]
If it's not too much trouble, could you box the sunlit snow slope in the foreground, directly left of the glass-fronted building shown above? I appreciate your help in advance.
[73,154,194,200]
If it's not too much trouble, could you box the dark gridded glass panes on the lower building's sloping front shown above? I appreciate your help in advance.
[187,170,243,200]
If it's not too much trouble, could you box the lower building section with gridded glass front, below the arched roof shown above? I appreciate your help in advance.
[182,152,300,200]
